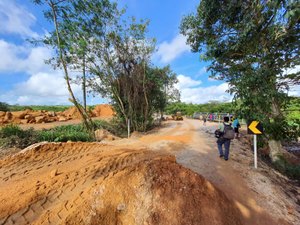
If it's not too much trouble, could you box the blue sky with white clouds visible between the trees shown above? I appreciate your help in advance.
[0,0,300,105]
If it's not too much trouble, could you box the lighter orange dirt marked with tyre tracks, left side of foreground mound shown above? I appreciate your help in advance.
[0,143,169,224]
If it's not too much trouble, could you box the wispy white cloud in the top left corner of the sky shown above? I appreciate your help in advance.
[0,0,38,38]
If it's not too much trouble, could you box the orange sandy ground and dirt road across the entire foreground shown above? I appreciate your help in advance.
[0,120,300,225]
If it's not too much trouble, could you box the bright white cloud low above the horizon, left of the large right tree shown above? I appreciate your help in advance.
[177,75,232,103]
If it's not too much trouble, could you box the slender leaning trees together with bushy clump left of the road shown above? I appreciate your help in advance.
[34,0,176,133]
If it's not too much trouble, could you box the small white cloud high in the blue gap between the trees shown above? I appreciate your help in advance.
[154,34,190,63]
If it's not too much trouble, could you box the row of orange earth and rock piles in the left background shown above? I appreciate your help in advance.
[0,105,114,124]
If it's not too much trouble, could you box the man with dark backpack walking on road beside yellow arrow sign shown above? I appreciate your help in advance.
[217,116,234,161]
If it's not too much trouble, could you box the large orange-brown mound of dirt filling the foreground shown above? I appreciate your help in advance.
[0,143,241,225]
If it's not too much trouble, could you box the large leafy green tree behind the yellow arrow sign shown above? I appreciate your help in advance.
[180,0,300,161]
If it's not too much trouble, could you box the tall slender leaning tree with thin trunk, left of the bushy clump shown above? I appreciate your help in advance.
[34,0,117,133]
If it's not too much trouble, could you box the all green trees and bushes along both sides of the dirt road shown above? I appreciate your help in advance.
[0,0,300,179]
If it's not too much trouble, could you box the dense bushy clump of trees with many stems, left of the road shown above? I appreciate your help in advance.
[89,18,176,131]
